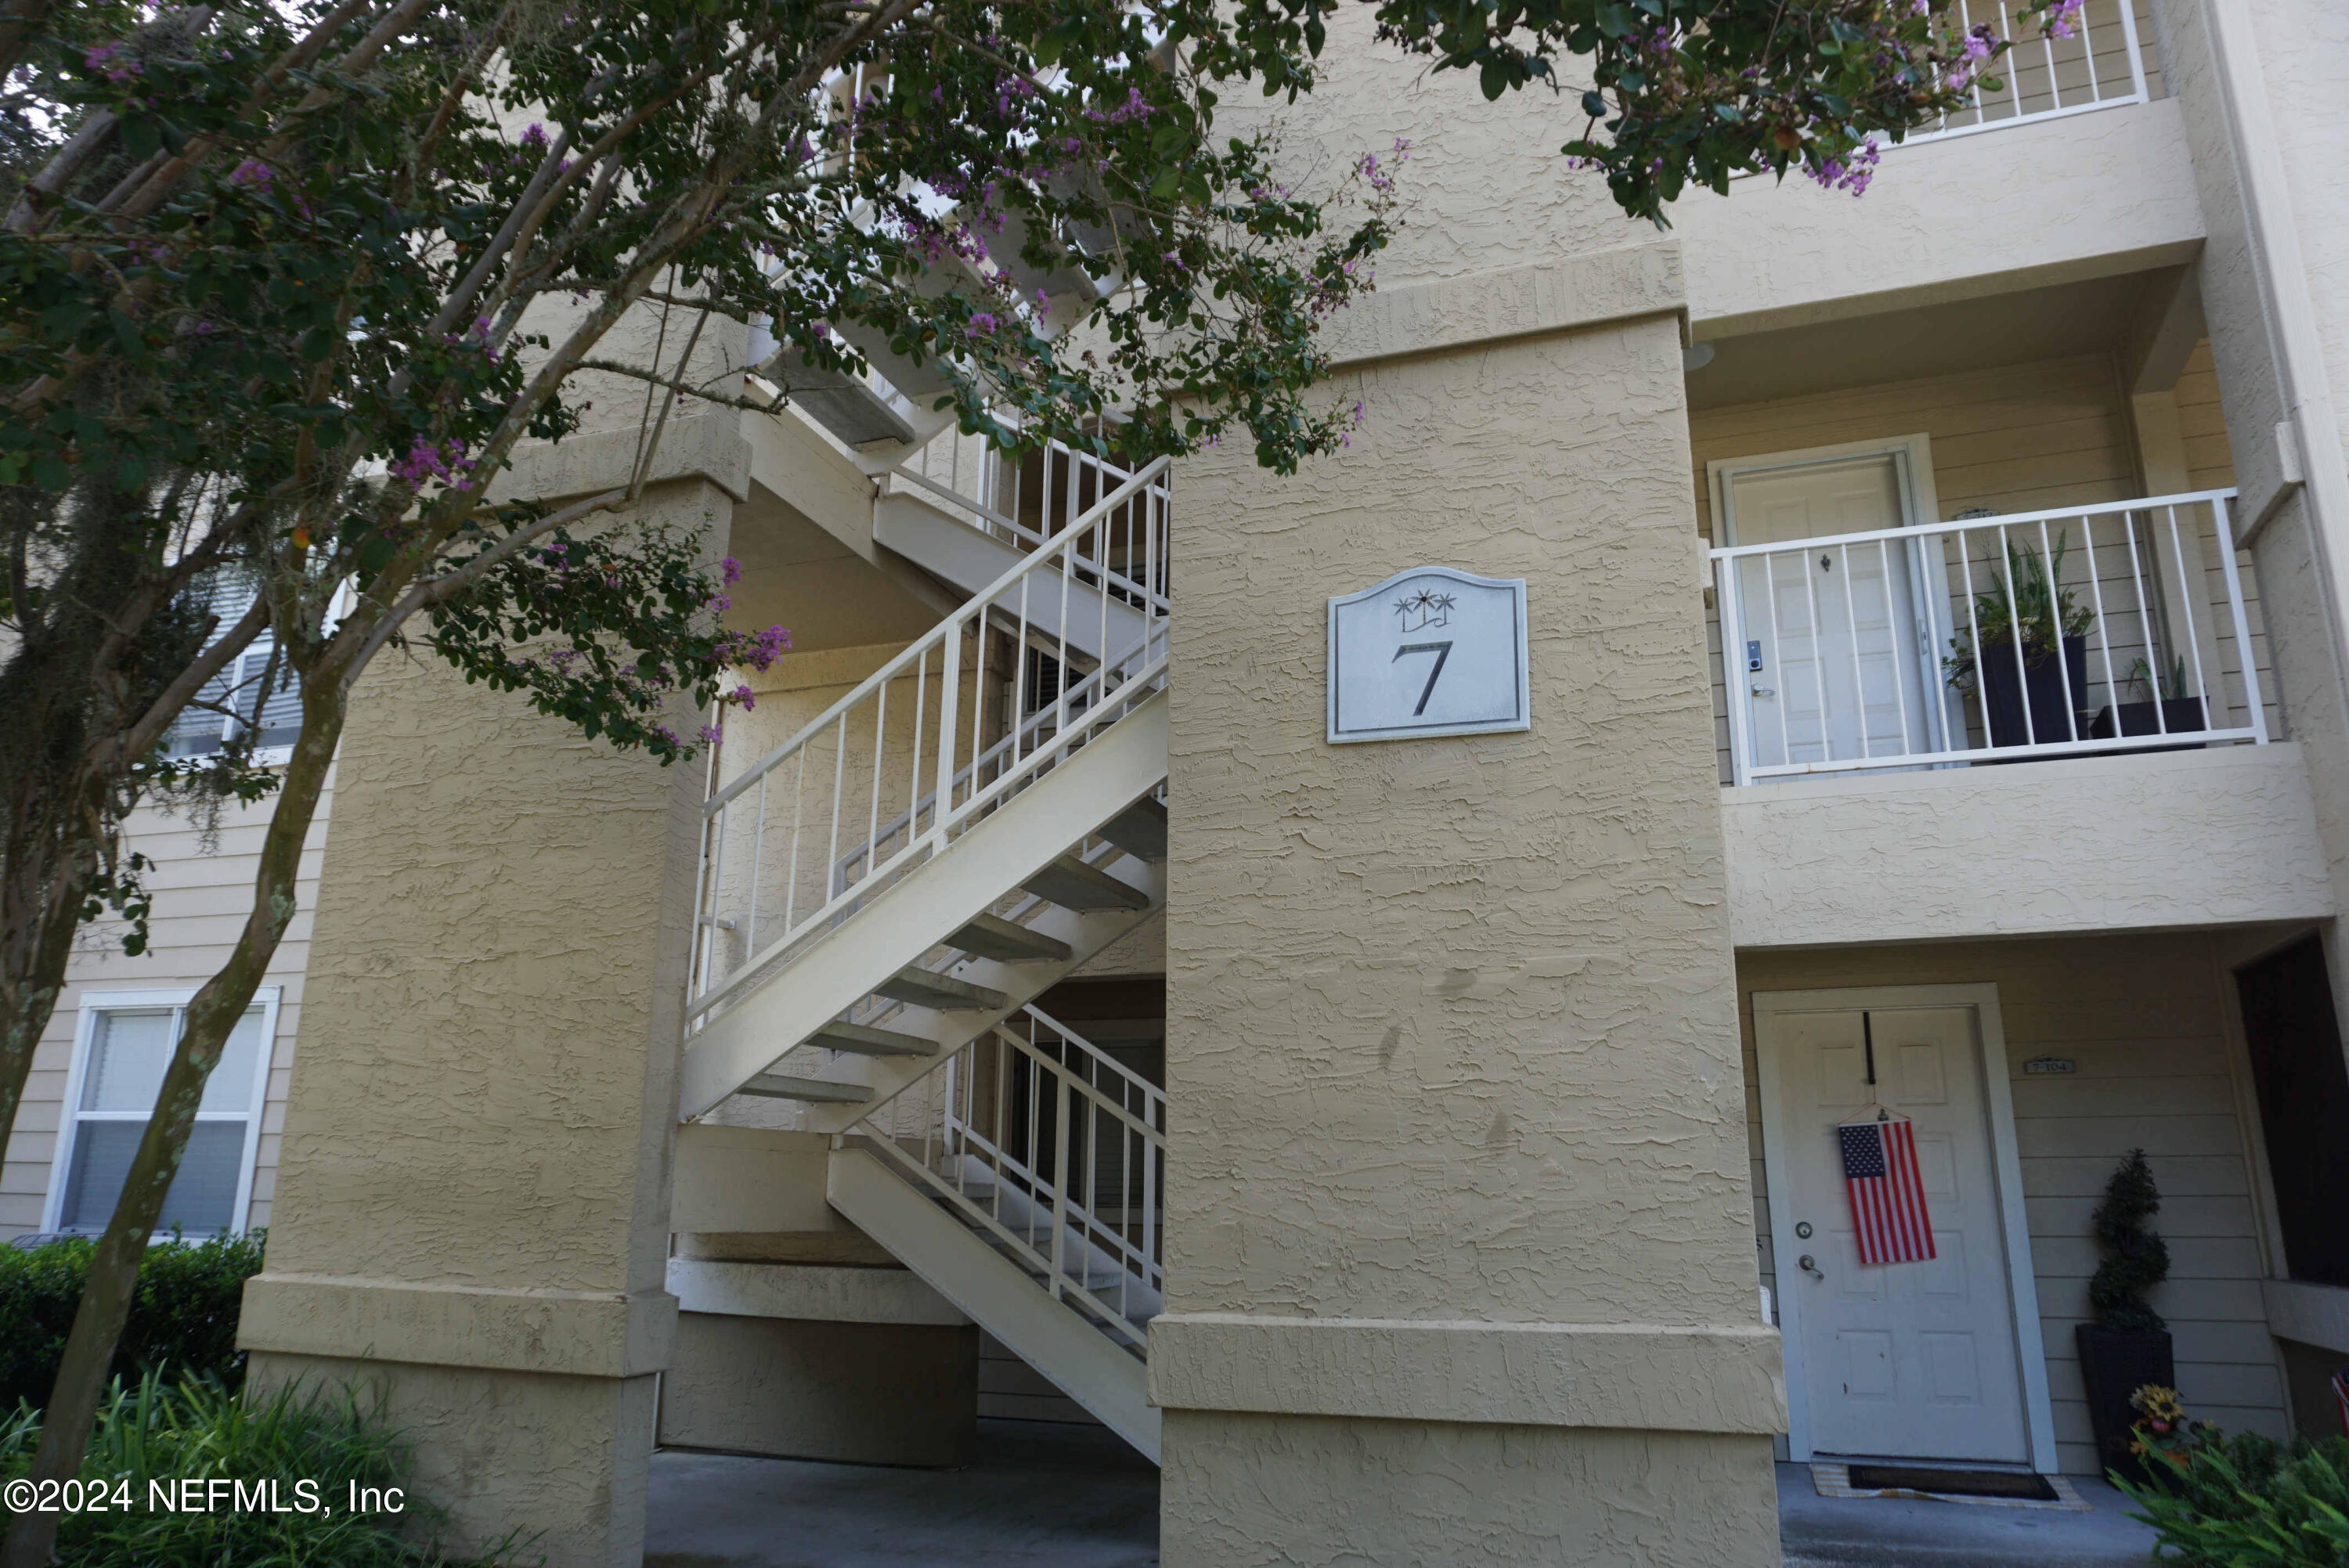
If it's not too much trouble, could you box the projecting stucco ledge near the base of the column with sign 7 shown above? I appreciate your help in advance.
[1151,1312,1785,1434]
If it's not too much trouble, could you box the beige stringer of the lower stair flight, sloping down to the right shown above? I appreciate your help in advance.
[824,1148,1158,1465]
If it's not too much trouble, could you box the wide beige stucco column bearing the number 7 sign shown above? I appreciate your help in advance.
[1151,242,1785,1568]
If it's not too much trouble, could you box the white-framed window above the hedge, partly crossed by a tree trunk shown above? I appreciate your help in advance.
[42,986,277,1237]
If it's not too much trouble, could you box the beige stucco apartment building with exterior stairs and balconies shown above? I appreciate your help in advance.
[7,0,2349,1568]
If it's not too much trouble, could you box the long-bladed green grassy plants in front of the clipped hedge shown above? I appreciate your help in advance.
[0,1373,538,1568]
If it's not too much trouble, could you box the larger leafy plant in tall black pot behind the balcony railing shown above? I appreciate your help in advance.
[1940,533,2095,747]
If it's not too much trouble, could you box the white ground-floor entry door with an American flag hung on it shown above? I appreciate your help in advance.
[1755,1007,2030,1462]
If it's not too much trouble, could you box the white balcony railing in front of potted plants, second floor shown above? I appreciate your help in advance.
[1712,491,2269,784]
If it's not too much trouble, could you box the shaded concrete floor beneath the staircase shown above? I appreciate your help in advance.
[644,1420,1158,1568]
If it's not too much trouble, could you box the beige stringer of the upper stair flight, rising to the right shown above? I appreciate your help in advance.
[677,690,1167,1131]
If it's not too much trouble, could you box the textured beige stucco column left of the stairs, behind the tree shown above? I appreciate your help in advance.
[240,474,733,1568]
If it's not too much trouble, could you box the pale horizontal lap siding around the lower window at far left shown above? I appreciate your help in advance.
[0,788,334,1239]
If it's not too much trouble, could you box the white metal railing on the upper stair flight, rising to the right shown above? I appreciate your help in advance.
[688,458,1170,1044]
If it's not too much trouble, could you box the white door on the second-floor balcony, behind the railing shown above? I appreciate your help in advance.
[1722,453,1940,768]
